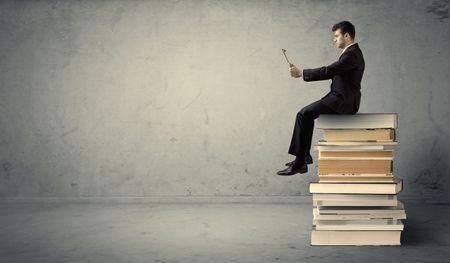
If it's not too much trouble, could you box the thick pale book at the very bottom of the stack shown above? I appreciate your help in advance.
[311,230,402,246]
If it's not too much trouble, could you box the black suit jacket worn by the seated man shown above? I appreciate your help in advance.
[303,43,365,114]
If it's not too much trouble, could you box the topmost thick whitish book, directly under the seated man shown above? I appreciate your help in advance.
[315,113,397,129]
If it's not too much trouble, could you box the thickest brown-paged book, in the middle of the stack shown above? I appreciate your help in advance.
[317,159,392,174]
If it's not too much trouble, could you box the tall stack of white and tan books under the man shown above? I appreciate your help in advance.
[310,114,406,248]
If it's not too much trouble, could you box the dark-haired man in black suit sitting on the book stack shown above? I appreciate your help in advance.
[277,21,365,176]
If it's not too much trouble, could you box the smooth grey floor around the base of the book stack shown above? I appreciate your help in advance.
[0,202,450,263]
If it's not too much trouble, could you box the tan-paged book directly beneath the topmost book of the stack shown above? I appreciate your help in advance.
[323,129,395,142]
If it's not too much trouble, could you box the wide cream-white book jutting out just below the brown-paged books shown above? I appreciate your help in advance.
[309,180,403,194]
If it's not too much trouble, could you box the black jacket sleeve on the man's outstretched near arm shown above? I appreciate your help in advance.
[303,52,357,81]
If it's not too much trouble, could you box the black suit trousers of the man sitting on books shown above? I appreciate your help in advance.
[289,100,338,160]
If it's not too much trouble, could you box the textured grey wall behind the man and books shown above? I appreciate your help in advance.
[0,0,450,200]
